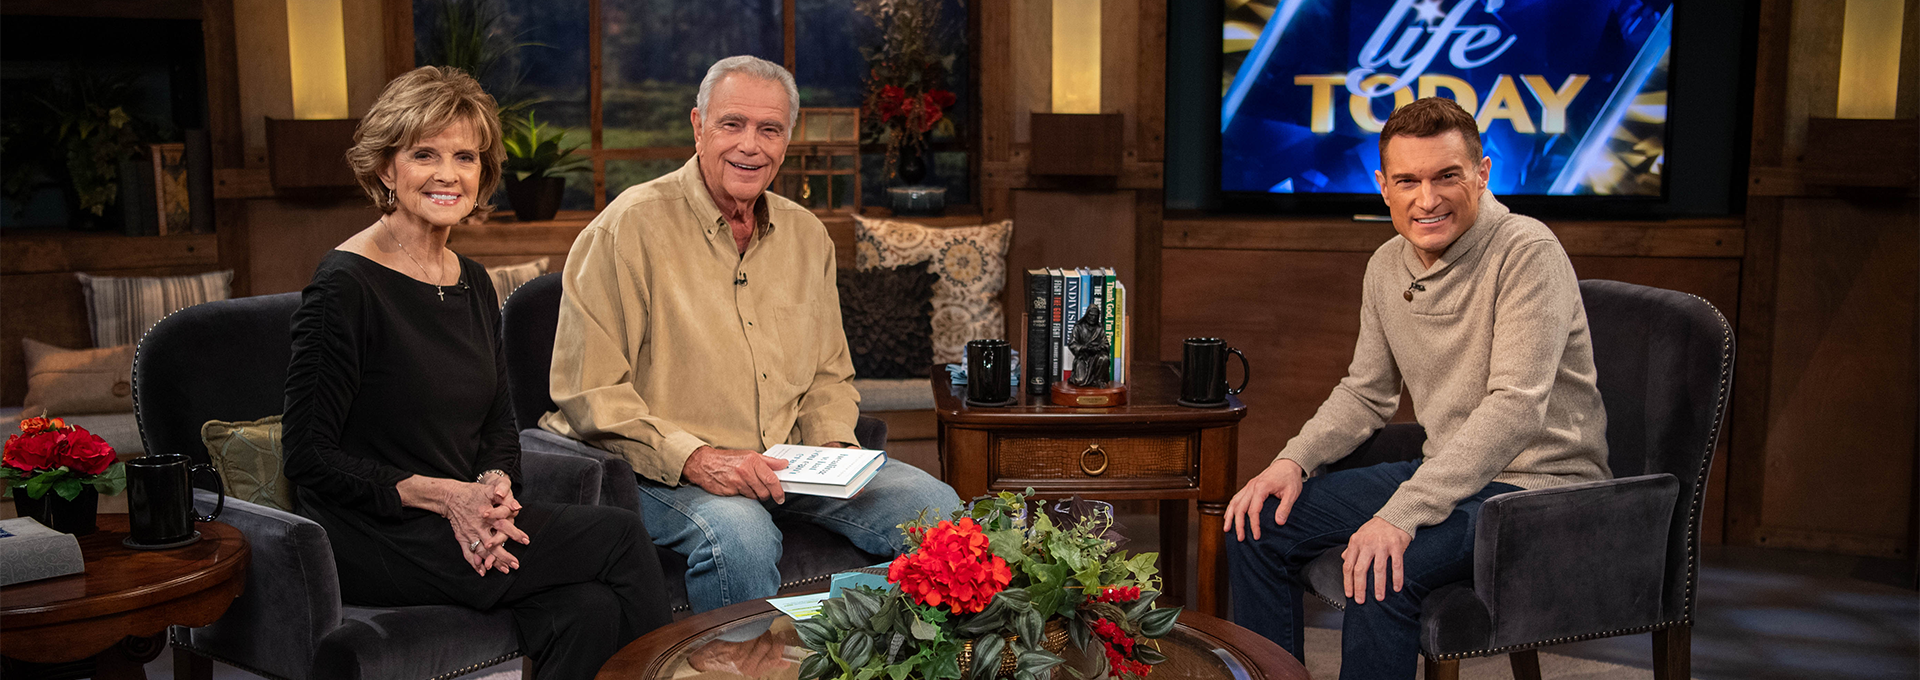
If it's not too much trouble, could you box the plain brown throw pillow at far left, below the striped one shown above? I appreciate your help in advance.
[19,338,132,415]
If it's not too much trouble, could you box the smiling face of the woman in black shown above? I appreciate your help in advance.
[380,121,480,227]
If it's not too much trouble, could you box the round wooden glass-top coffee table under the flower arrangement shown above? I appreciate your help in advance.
[597,599,1308,680]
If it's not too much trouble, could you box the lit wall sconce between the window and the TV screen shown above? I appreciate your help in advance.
[1027,0,1123,177]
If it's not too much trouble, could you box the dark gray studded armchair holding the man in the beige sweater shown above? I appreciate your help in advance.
[1306,280,1734,680]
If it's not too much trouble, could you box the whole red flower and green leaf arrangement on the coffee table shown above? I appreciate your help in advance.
[795,490,1181,680]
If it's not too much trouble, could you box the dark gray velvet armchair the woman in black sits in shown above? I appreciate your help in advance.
[132,294,601,680]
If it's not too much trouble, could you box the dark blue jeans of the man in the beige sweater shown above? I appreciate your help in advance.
[1221,461,1521,680]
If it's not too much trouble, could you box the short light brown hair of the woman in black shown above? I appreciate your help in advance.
[348,65,507,221]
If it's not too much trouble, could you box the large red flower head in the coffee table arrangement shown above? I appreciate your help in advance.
[887,519,1014,615]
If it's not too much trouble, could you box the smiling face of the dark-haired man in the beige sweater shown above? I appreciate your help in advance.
[1373,131,1494,267]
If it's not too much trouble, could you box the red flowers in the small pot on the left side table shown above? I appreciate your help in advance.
[0,417,127,501]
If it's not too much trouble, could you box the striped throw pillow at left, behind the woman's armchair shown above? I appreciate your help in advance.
[75,269,234,348]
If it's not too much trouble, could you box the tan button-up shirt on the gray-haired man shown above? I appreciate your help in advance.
[540,158,860,484]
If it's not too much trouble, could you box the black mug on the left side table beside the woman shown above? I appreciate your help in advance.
[127,453,227,547]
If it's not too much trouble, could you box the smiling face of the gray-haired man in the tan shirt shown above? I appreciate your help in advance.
[691,73,791,213]
